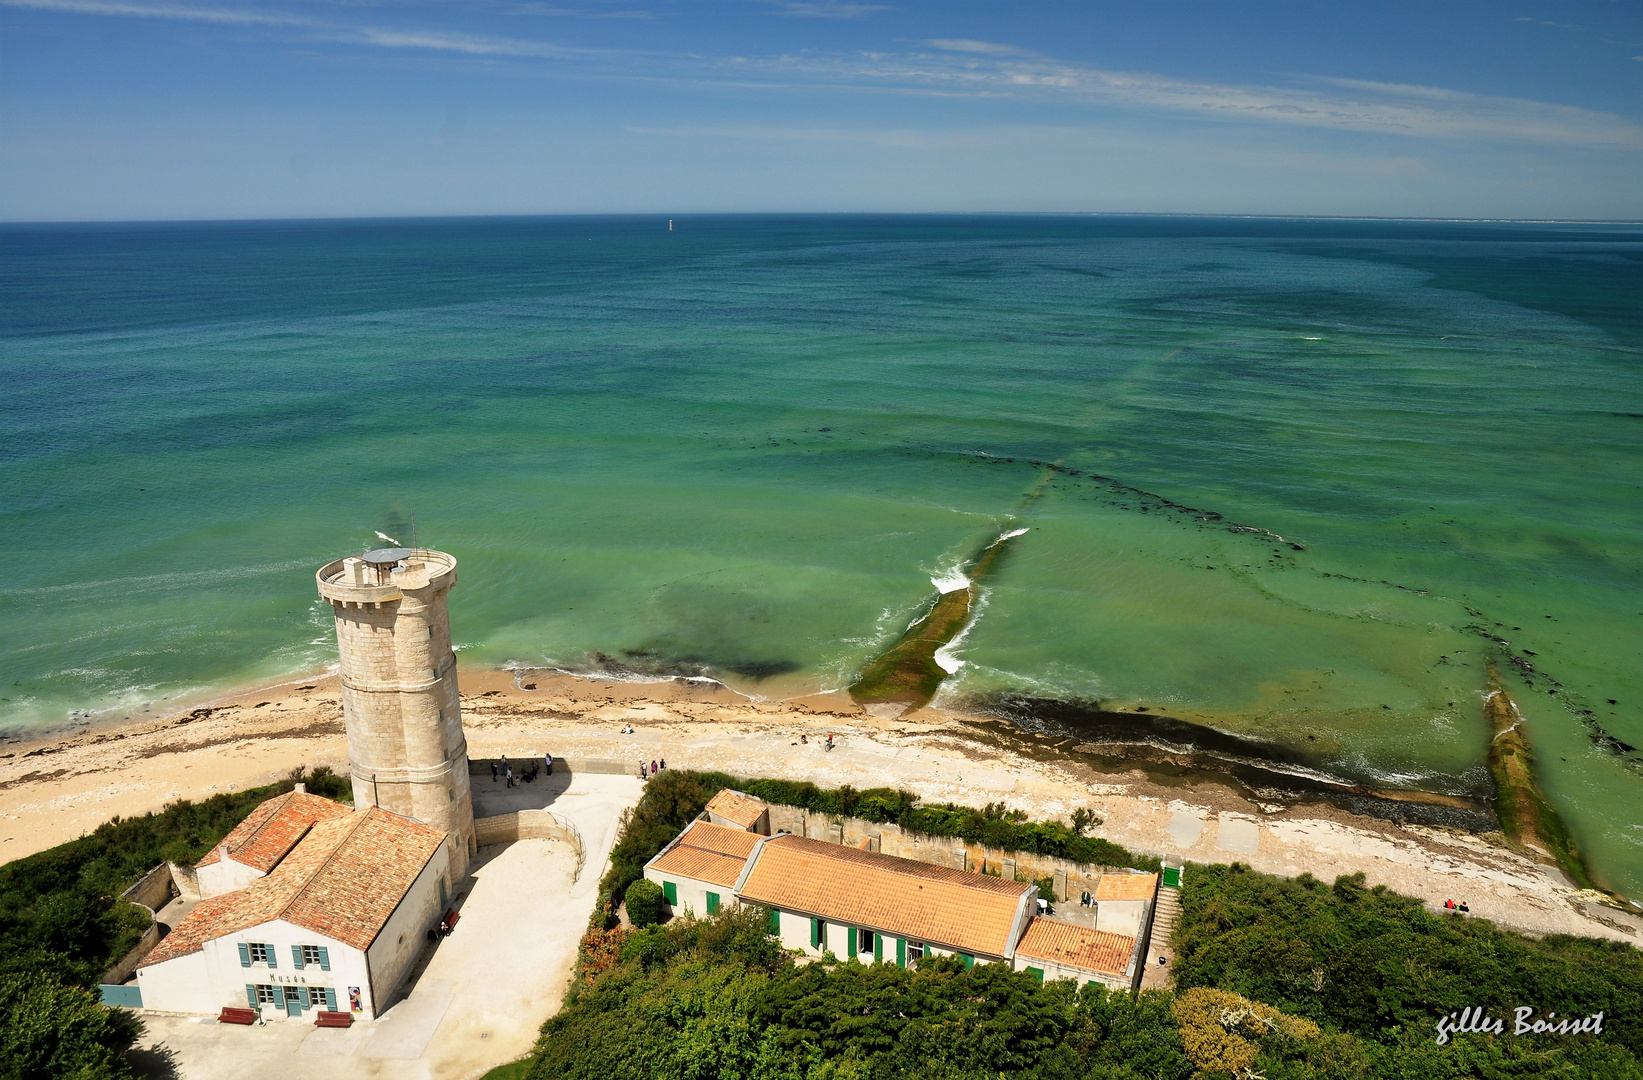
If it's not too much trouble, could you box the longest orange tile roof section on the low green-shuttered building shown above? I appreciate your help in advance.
[739,835,1035,957]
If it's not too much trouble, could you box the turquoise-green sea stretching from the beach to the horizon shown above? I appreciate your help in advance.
[0,215,1643,898]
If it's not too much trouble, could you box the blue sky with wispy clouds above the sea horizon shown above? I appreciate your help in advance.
[0,0,1643,220]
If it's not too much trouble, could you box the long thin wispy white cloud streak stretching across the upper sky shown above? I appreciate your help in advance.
[12,0,1643,150]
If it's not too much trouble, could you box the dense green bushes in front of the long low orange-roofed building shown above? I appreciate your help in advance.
[529,909,1191,1080]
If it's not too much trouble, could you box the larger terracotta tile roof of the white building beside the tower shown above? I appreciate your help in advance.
[141,804,445,967]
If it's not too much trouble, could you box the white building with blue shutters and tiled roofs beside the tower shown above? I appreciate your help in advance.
[136,792,452,1019]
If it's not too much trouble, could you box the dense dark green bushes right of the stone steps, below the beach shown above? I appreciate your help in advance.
[1175,865,1643,1075]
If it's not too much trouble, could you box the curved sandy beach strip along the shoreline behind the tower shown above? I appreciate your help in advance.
[0,669,1643,945]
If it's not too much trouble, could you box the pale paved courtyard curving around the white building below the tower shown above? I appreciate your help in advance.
[133,774,641,1080]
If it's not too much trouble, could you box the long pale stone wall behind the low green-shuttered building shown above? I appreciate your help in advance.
[771,802,1132,901]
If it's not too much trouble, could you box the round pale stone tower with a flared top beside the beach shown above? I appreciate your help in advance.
[315,547,475,878]
